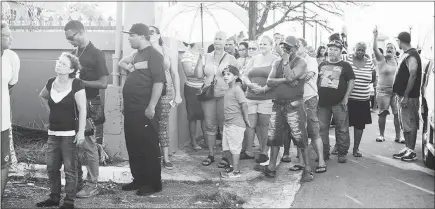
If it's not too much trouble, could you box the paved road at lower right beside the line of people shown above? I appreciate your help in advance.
[291,114,434,208]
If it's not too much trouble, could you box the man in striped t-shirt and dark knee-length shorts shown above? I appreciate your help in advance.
[344,42,375,157]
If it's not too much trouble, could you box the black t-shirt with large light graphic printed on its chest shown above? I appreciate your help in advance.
[317,60,355,107]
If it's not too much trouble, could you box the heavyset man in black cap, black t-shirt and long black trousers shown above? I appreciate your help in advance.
[118,23,166,196]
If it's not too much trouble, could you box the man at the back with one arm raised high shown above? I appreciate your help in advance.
[373,28,405,143]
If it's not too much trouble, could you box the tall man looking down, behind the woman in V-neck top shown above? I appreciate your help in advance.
[64,20,109,198]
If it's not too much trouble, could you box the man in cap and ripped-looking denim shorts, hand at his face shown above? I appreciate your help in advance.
[264,36,313,182]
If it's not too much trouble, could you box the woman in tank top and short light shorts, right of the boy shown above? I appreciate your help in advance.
[240,36,277,163]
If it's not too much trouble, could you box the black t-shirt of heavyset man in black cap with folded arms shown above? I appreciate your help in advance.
[122,46,166,112]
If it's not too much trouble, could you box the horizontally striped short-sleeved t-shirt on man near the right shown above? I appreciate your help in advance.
[344,54,375,101]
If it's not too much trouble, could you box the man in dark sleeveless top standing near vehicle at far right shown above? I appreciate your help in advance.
[393,32,422,161]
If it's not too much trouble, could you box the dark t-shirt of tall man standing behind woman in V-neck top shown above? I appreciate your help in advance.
[73,42,109,99]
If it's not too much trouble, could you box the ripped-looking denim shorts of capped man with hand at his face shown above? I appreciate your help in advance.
[267,100,308,149]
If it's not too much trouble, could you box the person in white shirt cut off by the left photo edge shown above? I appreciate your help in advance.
[0,21,20,197]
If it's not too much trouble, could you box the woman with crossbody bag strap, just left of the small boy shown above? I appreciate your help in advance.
[195,31,237,167]
